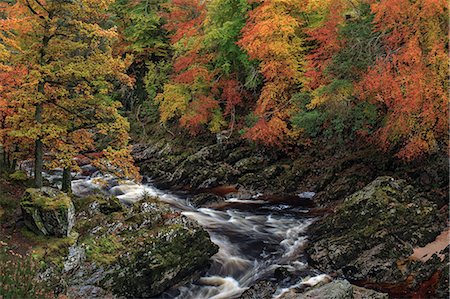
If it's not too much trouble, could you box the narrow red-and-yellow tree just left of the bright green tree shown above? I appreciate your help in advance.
[155,0,219,134]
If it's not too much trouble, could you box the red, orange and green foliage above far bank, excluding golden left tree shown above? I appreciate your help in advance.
[138,0,448,160]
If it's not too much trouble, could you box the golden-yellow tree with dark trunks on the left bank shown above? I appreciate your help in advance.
[1,0,138,189]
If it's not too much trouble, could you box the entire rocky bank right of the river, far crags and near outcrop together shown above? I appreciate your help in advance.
[134,138,449,298]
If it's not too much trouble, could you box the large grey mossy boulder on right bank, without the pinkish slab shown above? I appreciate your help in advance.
[307,177,445,290]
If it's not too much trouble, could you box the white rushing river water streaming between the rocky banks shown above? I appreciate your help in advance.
[41,166,318,299]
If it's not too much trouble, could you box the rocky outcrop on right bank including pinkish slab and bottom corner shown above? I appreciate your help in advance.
[307,177,449,298]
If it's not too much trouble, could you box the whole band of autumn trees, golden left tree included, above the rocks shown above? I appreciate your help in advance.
[0,0,448,186]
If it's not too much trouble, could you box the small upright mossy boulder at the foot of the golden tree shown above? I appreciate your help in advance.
[20,187,75,237]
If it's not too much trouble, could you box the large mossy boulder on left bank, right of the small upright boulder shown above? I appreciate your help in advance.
[36,195,218,298]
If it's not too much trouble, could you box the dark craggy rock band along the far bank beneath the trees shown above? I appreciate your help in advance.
[133,135,448,208]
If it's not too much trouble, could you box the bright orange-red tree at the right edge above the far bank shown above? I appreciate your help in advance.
[357,0,449,160]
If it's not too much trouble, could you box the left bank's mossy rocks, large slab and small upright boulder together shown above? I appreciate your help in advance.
[21,188,218,298]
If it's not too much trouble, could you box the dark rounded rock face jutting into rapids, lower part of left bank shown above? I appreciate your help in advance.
[103,224,218,298]
